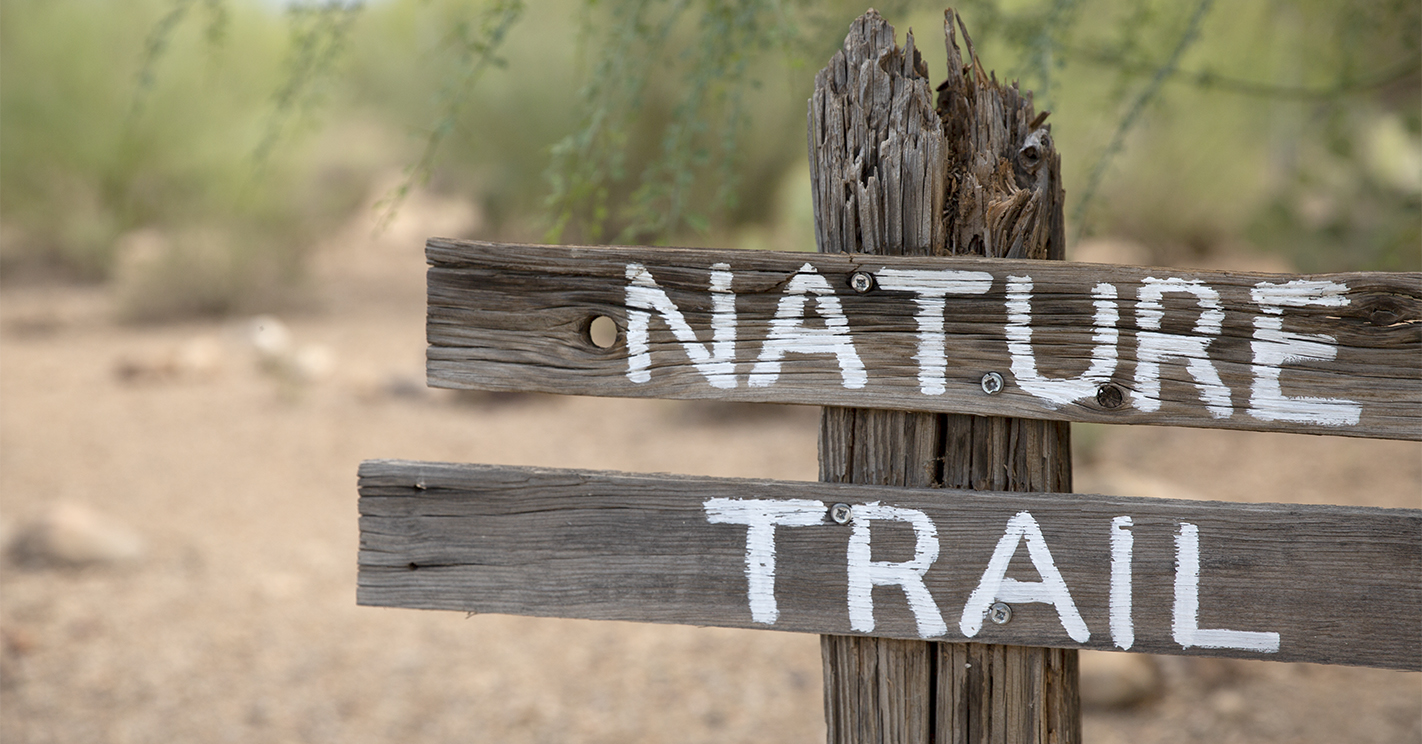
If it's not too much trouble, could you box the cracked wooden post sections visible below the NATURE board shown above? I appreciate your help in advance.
[819,408,1081,744]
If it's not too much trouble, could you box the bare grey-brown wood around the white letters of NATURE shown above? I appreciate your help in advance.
[427,239,1422,440]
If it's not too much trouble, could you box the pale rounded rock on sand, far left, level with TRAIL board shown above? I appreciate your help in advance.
[10,504,144,568]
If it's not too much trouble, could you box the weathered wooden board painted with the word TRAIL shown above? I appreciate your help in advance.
[358,461,1422,670]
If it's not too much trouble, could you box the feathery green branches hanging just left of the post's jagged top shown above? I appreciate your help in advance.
[547,0,795,240]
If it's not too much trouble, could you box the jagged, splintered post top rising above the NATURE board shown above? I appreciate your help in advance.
[808,10,1065,259]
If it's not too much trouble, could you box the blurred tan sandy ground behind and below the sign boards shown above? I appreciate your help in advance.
[0,223,1422,744]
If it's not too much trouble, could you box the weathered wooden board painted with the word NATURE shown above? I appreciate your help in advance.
[427,239,1422,440]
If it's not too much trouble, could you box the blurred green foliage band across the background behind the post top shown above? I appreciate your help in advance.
[0,0,1422,316]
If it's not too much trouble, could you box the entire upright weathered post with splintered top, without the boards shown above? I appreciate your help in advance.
[809,10,1081,744]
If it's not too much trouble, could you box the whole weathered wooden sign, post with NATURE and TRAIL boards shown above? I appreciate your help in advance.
[358,10,1422,744]
